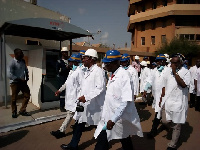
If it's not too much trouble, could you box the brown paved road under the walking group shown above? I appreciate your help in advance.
[0,103,200,150]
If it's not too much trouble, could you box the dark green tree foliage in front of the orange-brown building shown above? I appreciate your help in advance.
[156,38,200,58]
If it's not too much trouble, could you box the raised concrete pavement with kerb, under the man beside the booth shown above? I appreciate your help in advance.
[0,100,65,133]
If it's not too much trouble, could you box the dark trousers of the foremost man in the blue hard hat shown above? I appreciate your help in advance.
[95,130,133,150]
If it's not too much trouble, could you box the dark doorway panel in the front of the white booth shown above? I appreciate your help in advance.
[41,50,60,103]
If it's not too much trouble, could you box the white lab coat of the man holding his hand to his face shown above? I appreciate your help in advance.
[162,67,190,123]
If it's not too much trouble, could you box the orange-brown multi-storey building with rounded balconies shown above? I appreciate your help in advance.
[128,0,200,52]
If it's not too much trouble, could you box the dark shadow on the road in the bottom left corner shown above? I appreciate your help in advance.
[0,130,29,148]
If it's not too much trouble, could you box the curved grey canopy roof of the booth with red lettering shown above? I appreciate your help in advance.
[0,18,92,41]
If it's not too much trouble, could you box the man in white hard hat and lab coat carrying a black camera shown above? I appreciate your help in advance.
[61,49,106,150]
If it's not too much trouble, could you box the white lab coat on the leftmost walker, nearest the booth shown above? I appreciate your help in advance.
[59,67,84,112]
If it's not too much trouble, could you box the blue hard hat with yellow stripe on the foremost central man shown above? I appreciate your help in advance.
[102,50,121,63]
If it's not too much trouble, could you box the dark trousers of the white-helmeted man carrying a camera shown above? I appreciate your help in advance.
[69,122,86,148]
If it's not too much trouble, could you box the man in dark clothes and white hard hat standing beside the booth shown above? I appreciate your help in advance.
[56,47,71,112]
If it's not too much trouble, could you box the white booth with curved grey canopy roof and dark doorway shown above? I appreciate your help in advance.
[0,18,92,109]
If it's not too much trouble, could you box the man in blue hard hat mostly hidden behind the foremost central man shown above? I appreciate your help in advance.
[120,53,139,100]
